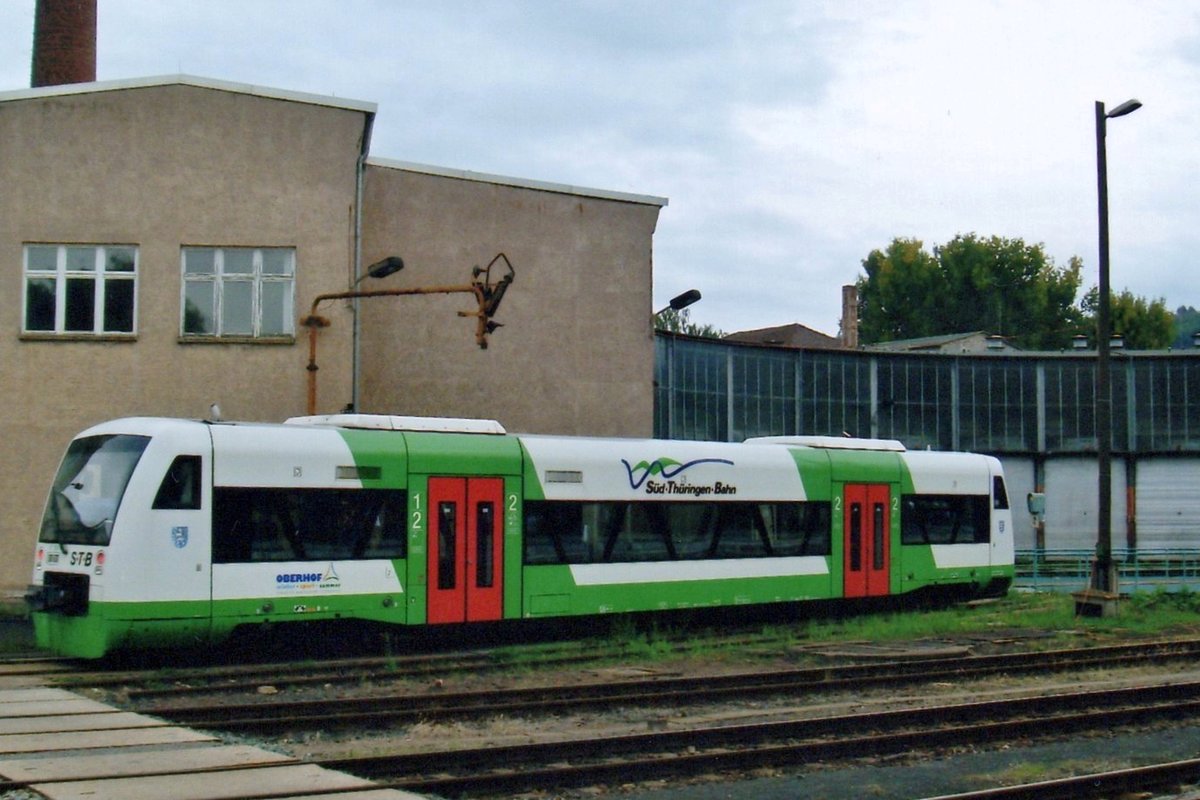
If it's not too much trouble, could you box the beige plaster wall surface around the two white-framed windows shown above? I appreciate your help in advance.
[0,82,373,591]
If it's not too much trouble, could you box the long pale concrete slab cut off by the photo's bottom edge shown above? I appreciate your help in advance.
[30,764,371,800]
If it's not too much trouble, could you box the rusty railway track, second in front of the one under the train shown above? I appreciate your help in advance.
[322,684,1200,799]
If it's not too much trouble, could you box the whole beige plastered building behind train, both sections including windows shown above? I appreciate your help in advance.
[0,76,666,596]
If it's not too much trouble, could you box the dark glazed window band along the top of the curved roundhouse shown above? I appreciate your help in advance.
[654,333,1200,455]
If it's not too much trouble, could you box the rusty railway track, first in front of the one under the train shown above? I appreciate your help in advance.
[140,640,1200,734]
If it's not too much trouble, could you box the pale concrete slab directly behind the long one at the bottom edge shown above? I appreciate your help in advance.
[0,744,295,782]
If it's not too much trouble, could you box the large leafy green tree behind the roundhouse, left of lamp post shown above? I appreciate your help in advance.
[858,234,1084,350]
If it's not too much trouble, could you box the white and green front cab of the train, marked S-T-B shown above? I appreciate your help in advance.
[25,420,209,658]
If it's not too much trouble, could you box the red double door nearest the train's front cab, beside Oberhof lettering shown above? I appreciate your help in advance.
[426,477,504,622]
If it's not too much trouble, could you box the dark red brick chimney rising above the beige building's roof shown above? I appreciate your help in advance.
[30,0,96,89]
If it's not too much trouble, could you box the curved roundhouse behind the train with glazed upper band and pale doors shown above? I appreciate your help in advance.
[654,331,1200,557]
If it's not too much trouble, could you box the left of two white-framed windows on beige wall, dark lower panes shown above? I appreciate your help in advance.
[23,245,138,336]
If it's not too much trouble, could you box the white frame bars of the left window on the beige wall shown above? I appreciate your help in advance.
[20,242,139,338]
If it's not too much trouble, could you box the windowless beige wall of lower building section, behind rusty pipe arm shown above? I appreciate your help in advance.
[355,161,665,437]
